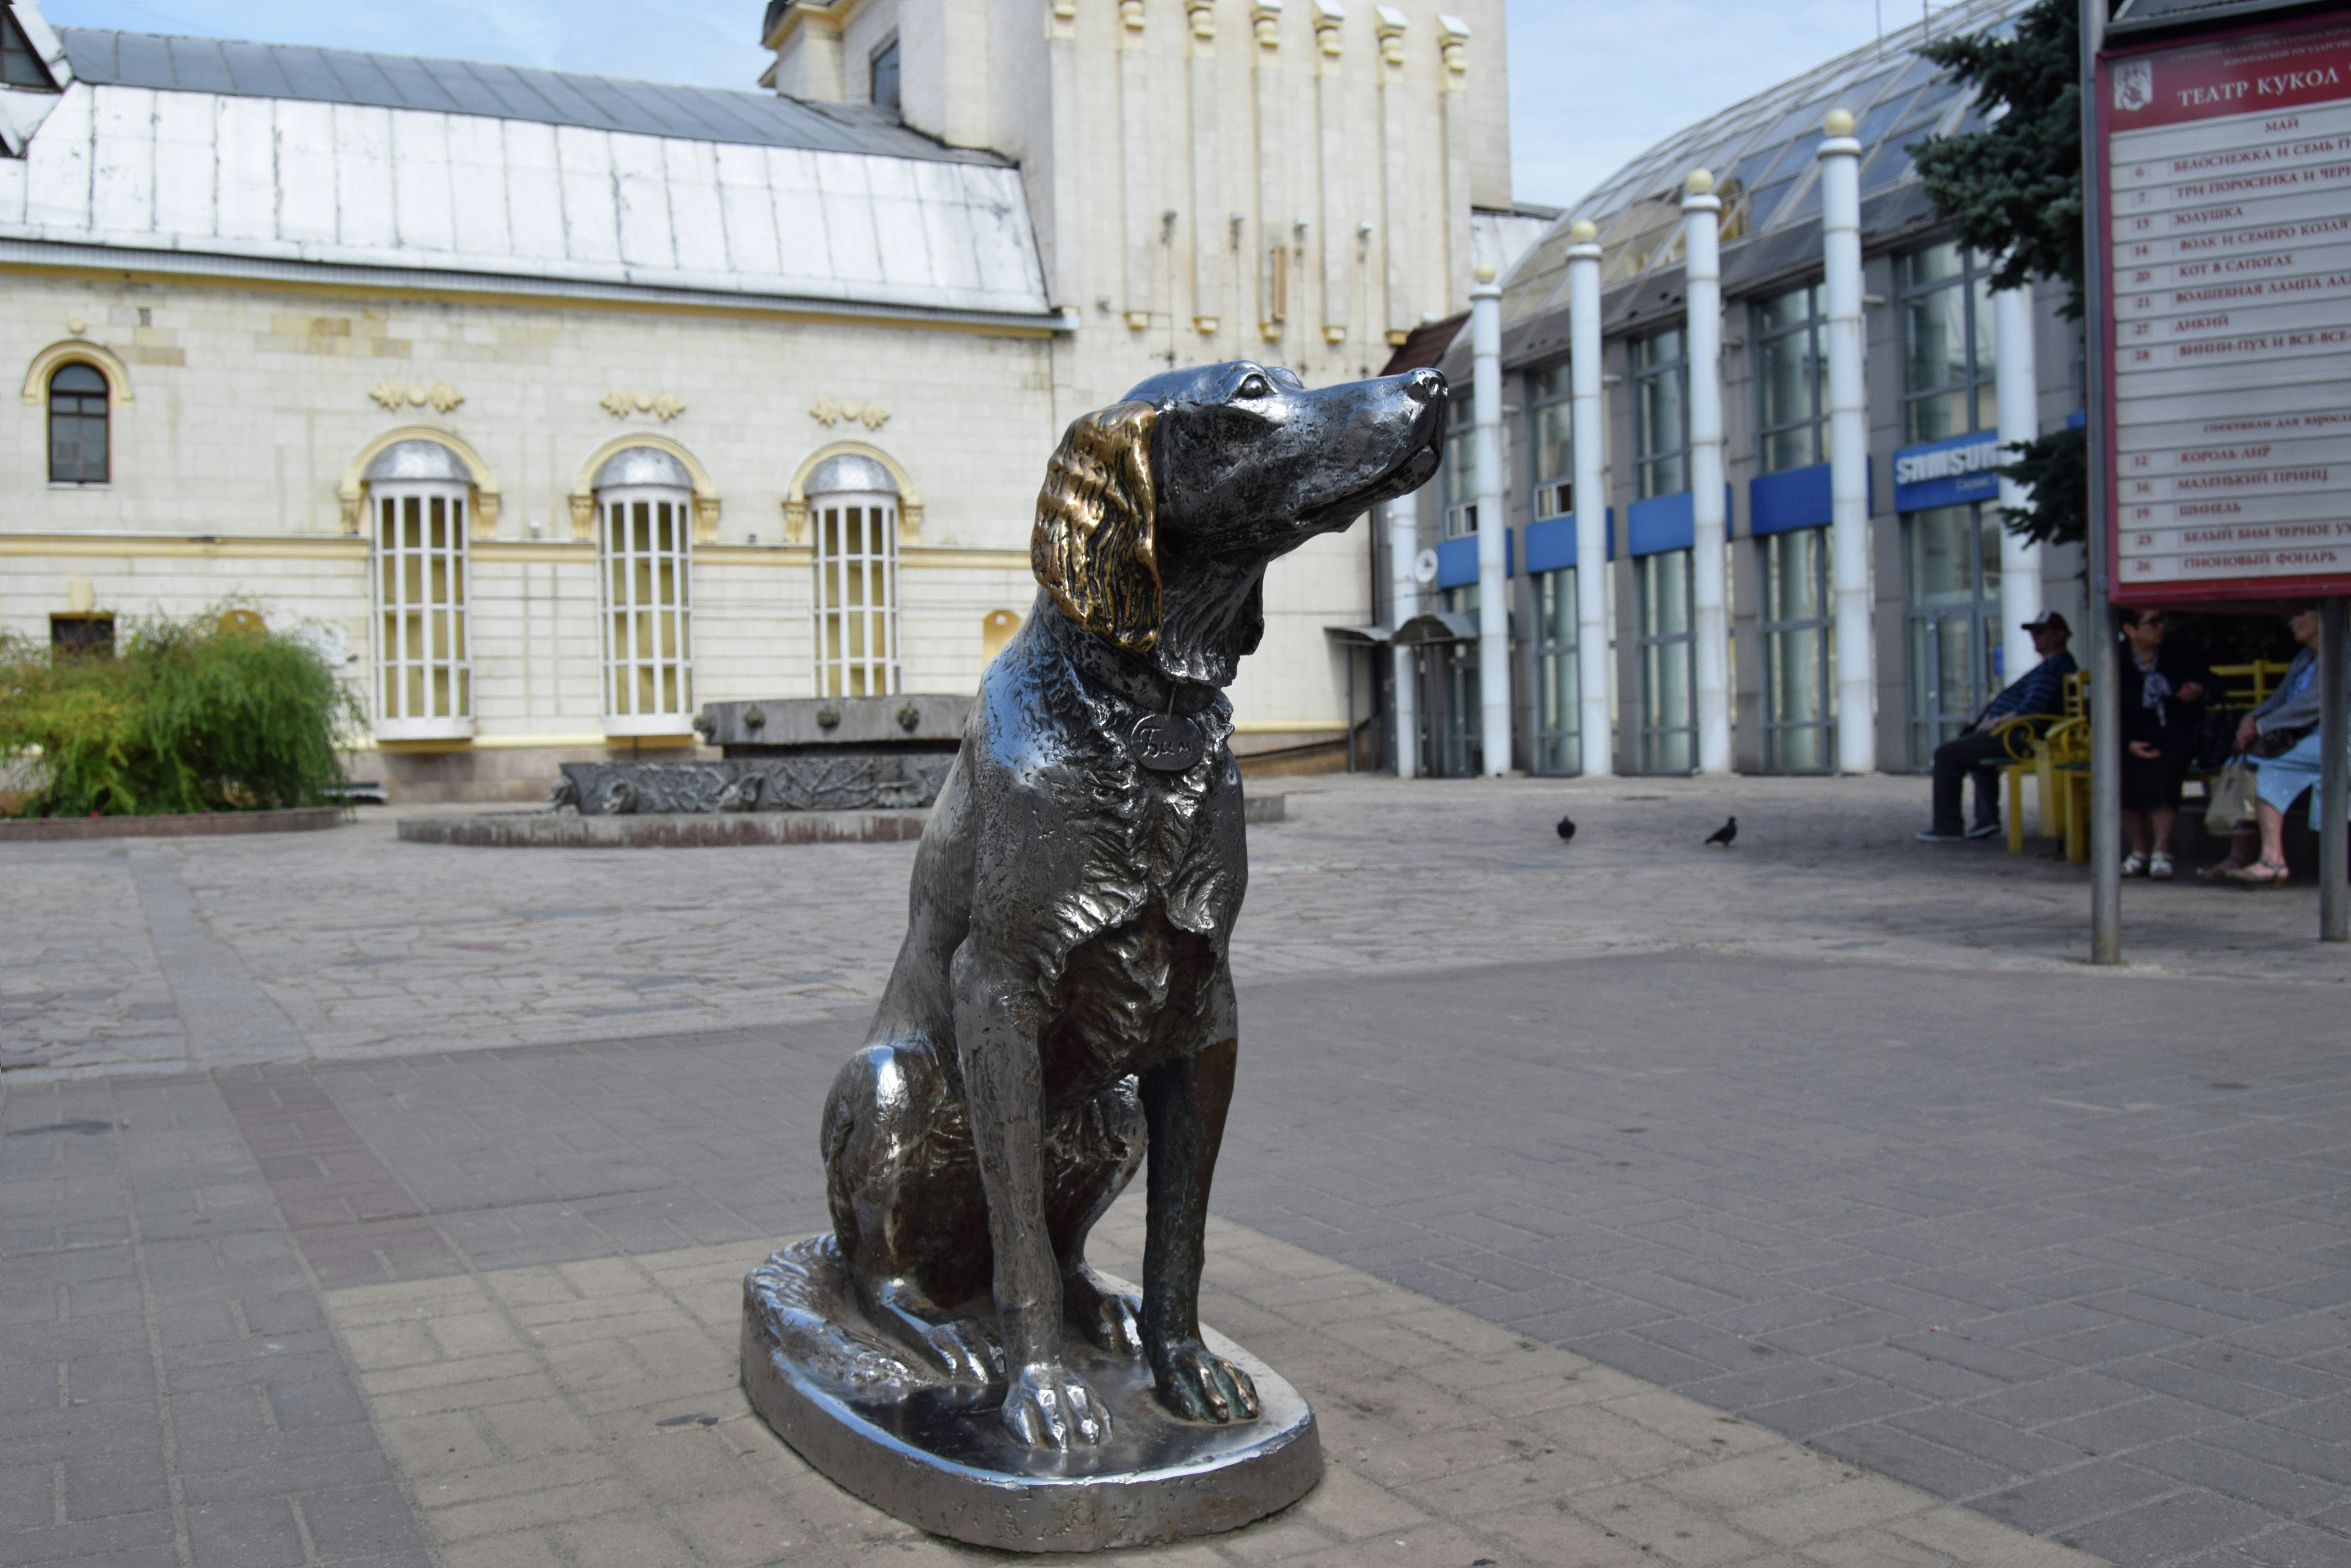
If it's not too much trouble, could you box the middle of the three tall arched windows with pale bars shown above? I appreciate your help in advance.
[592,447,694,736]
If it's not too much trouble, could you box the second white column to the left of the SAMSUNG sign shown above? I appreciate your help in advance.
[1681,169,1730,773]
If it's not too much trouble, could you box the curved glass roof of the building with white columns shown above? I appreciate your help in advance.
[1502,0,2031,322]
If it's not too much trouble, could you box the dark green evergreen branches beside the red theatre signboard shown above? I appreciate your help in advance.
[1909,0,2090,543]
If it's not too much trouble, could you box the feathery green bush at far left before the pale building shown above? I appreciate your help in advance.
[0,609,362,816]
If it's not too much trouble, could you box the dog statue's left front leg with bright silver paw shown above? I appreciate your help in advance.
[955,940,1110,1448]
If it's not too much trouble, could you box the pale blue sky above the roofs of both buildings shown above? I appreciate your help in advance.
[42,0,1921,207]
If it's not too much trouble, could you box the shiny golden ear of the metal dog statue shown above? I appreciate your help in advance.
[1030,402,1159,654]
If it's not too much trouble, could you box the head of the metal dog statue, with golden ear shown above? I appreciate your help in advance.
[1030,360,1446,686]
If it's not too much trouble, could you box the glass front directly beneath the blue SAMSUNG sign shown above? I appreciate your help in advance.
[1902,505,2003,766]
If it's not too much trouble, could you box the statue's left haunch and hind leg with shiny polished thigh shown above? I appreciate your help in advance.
[823,1034,1004,1382]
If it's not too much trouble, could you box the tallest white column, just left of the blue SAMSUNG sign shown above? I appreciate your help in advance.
[1820,108,1878,773]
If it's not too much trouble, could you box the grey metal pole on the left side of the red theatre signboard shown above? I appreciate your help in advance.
[2081,0,2123,964]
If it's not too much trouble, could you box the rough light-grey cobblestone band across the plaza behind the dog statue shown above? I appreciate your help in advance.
[0,778,2351,1072]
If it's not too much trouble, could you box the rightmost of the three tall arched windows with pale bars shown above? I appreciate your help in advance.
[807,451,898,696]
